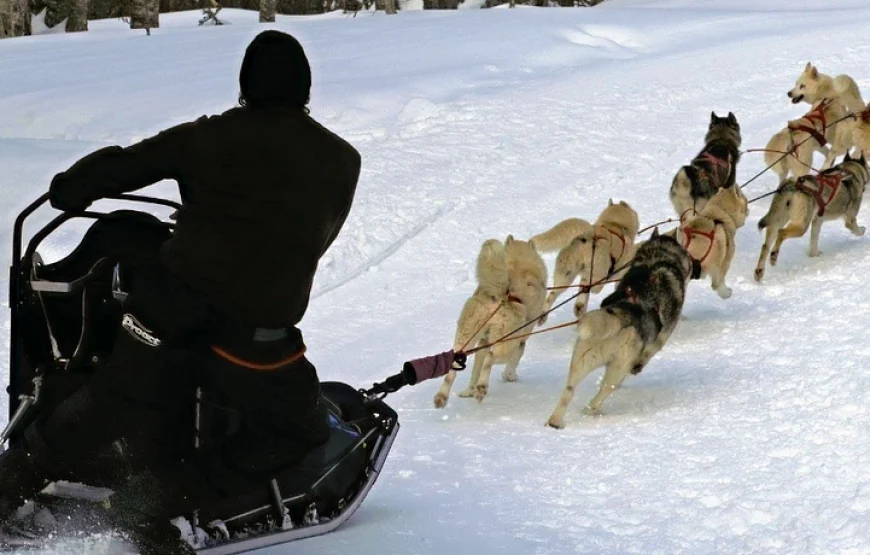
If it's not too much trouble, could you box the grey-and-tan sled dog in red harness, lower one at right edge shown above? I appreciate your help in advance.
[755,153,870,281]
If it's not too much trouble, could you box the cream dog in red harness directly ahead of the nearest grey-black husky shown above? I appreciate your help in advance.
[675,185,749,299]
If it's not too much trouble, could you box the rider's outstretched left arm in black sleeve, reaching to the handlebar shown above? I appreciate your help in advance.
[49,118,204,210]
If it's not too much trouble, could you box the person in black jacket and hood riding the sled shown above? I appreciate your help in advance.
[0,31,360,555]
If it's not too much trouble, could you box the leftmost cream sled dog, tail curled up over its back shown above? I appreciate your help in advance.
[434,235,547,408]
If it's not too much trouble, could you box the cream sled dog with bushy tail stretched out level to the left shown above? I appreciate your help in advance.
[532,199,640,323]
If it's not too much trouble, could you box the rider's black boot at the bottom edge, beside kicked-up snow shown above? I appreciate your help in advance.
[108,473,196,555]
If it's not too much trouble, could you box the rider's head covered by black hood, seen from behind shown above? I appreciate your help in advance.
[239,30,311,111]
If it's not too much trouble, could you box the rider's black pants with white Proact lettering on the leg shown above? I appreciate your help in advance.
[25,265,328,516]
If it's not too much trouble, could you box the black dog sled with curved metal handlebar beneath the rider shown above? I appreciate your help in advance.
[2,197,399,555]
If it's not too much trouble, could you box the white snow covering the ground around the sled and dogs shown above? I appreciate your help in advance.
[0,0,870,555]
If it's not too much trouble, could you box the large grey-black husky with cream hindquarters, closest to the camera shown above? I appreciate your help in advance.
[547,230,700,428]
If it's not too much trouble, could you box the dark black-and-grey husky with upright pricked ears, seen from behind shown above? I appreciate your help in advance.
[671,112,742,217]
